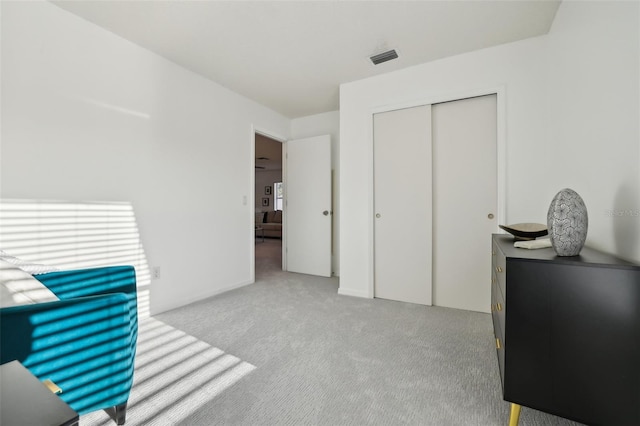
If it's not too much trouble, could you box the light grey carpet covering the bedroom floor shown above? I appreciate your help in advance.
[81,239,577,426]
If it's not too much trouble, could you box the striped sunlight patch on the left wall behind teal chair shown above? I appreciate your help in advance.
[0,199,151,318]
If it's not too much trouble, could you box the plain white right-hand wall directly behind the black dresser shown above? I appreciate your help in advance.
[546,1,640,262]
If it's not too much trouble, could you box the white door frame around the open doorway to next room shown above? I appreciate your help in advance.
[252,124,287,283]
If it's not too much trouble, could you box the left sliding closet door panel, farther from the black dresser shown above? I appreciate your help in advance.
[373,105,432,305]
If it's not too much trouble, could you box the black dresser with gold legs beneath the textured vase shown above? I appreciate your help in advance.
[491,234,640,426]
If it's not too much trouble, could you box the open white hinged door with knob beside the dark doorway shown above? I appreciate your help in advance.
[284,135,332,277]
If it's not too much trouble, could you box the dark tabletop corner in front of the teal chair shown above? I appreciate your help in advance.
[0,361,78,426]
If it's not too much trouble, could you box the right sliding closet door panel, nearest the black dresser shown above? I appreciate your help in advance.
[432,95,498,312]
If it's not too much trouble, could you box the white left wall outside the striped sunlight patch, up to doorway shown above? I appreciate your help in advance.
[0,2,290,313]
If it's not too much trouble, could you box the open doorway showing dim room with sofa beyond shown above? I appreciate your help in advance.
[254,133,283,280]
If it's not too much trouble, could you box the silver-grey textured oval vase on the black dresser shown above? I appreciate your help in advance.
[547,188,589,256]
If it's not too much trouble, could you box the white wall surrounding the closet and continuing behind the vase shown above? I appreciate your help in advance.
[340,2,640,297]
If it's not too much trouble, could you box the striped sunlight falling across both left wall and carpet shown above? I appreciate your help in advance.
[0,199,256,426]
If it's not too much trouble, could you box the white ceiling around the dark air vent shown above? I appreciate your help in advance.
[53,0,559,118]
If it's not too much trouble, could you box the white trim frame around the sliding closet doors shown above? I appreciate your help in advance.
[366,86,507,299]
